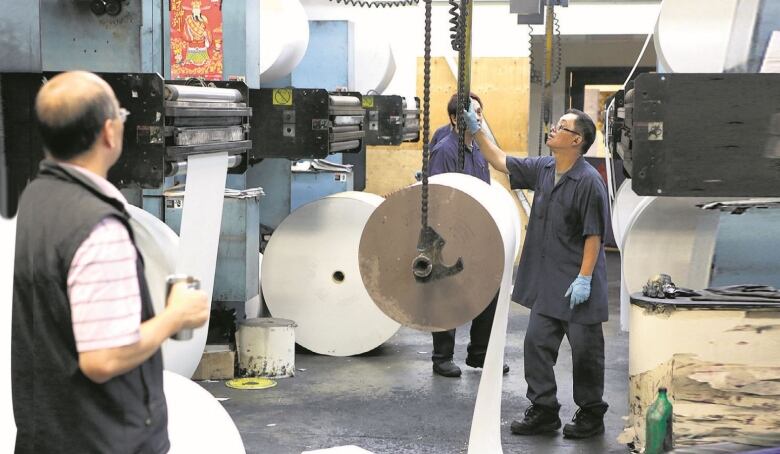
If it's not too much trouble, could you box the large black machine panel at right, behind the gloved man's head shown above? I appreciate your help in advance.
[608,73,780,197]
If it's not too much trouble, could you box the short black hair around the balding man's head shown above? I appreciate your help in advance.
[36,90,118,161]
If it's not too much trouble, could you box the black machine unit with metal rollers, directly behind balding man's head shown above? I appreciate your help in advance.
[0,72,253,208]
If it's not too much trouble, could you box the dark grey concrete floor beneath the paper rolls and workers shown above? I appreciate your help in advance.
[202,253,628,454]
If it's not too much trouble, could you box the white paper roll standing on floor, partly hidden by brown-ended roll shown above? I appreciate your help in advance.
[262,192,399,356]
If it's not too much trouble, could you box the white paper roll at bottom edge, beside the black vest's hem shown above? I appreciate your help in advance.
[163,371,246,454]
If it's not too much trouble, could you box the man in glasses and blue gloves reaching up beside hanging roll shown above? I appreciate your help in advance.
[466,109,608,438]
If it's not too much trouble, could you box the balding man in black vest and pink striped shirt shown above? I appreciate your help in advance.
[11,72,209,453]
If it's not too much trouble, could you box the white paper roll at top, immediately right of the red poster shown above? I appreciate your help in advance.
[262,0,309,83]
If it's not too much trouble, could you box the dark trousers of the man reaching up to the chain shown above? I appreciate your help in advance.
[523,309,608,414]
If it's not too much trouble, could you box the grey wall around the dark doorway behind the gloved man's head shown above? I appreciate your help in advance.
[528,35,656,156]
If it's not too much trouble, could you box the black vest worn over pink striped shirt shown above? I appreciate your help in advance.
[11,161,170,453]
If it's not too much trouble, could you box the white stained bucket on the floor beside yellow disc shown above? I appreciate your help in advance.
[236,318,297,378]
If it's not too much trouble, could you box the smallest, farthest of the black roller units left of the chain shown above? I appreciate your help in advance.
[363,95,420,145]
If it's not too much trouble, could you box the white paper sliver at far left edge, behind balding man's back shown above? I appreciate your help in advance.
[0,216,16,452]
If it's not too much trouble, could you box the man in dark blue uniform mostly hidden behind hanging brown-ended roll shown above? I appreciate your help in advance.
[429,93,509,377]
